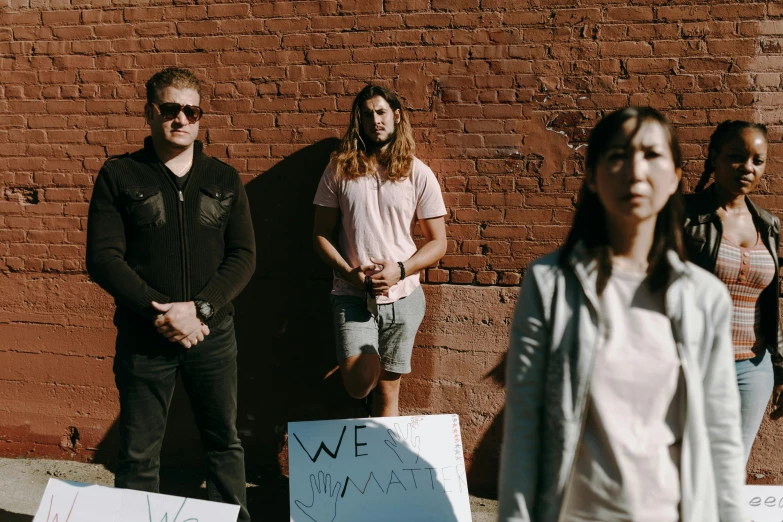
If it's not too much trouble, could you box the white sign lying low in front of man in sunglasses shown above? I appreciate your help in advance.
[33,479,239,522]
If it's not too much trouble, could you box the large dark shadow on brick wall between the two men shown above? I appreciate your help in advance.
[234,135,360,464]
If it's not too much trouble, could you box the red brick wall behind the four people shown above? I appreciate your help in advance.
[0,0,783,489]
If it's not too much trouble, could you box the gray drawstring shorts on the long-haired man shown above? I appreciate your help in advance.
[331,286,425,373]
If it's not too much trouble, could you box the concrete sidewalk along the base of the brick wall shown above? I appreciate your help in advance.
[0,459,497,522]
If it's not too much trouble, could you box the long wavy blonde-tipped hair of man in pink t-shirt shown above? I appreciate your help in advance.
[331,85,416,181]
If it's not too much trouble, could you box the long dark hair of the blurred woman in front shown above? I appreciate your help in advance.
[559,107,686,295]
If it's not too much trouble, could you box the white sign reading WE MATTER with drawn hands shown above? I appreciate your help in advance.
[288,415,471,522]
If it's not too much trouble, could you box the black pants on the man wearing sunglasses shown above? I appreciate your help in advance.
[114,316,250,522]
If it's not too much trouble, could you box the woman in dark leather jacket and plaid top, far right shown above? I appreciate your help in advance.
[685,120,783,461]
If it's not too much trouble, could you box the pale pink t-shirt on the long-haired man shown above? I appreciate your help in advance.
[313,158,446,304]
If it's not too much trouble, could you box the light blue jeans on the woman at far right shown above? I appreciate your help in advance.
[735,350,774,462]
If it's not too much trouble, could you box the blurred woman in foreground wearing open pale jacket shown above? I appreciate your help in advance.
[499,107,745,522]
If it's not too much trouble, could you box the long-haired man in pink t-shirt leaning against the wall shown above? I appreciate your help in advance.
[313,85,446,417]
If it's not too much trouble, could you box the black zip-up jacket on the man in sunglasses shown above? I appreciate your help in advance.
[87,138,256,327]
